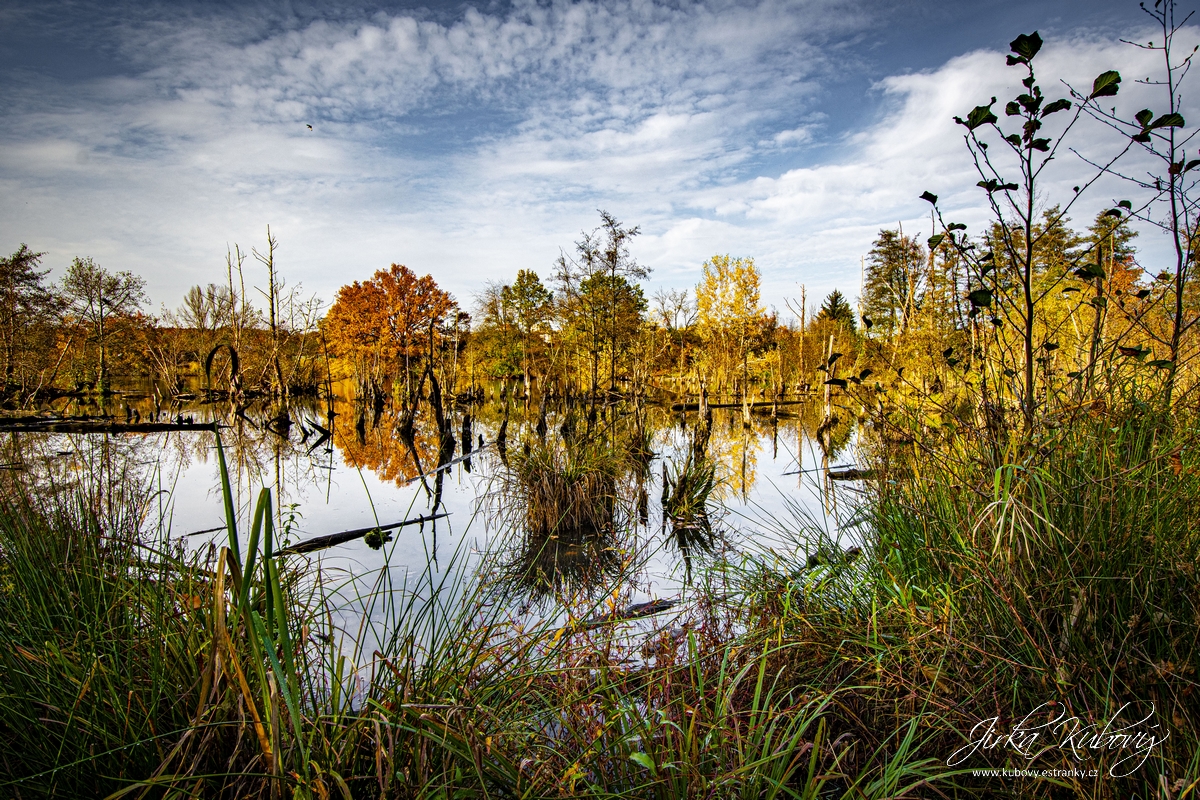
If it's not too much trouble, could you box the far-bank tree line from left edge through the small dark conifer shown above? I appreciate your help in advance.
[0,212,857,405]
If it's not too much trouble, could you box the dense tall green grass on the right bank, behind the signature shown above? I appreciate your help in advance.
[750,407,1200,798]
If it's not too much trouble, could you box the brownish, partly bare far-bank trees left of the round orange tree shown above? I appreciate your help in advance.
[0,231,326,407]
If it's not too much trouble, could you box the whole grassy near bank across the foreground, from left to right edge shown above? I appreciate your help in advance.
[0,407,1200,800]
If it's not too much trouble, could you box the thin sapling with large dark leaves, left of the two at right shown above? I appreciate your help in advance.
[922,20,1142,435]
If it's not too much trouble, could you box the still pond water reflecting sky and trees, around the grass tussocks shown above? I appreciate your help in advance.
[2,383,854,642]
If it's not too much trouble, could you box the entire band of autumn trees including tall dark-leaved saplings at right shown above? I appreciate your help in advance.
[0,15,1200,438]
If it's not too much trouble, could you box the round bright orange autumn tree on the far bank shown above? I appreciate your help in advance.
[324,264,457,397]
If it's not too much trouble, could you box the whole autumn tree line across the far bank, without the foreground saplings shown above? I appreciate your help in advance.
[7,182,1200,429]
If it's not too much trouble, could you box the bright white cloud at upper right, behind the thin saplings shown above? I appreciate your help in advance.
[648,25,1200,314]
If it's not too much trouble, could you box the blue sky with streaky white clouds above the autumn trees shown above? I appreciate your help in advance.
[0,0,1188,319]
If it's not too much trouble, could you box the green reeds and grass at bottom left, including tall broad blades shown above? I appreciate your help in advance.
[0,440,362,798]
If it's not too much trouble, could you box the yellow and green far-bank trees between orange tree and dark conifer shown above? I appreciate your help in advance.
[451,212,858,398]
